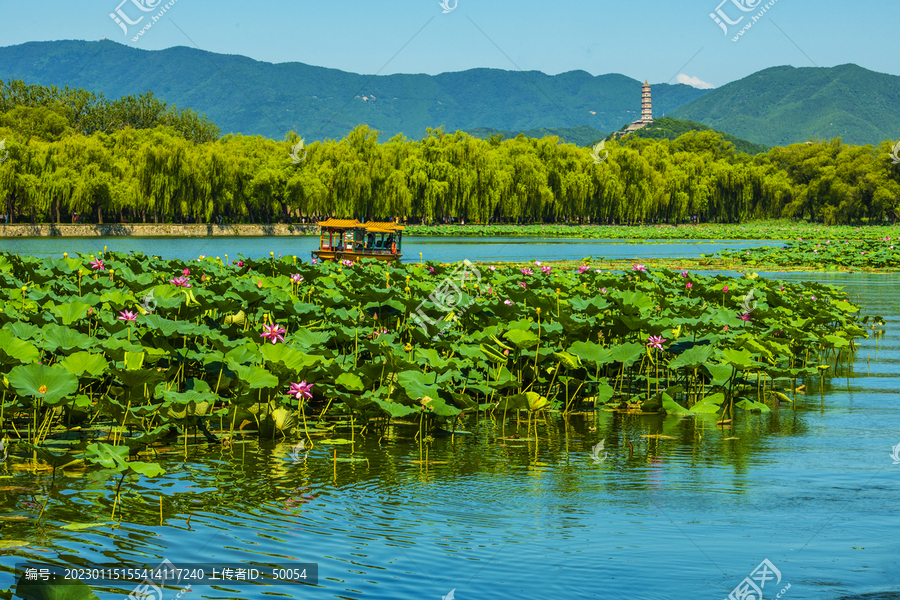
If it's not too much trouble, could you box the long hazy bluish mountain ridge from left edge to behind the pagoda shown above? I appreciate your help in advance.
[0,41,708,141]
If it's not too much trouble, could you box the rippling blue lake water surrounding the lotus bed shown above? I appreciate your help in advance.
[0,238,900,600]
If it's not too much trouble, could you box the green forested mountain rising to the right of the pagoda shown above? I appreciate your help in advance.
[668,65,900,146]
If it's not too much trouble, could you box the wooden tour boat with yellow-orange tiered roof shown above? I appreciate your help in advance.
[312,219,406,262]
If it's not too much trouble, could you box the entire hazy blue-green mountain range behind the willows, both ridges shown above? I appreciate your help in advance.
[0,40,900,146]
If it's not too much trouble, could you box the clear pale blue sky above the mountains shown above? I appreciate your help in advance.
[0,0,900,87]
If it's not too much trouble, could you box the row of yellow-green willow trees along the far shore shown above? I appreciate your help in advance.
[0,78,900,224]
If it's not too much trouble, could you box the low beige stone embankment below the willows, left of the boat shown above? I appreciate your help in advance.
[0,223,319,237]
